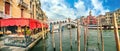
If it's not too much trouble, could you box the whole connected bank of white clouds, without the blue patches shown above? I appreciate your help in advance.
[40,0,109,20]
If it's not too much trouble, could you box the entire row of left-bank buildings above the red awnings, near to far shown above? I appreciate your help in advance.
[0,0,47,21]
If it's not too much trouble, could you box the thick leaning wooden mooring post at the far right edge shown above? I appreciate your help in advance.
[113,13,120,51]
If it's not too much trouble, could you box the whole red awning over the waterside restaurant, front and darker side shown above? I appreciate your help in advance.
[0,18,47,29]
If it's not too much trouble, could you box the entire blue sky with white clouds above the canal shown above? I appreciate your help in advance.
[40,0,120,20]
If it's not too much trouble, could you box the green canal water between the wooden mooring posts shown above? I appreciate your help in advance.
[31,28,116,51]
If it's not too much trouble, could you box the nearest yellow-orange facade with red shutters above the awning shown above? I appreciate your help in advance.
[0,0,30,18]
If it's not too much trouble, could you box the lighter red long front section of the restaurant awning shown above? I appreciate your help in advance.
[0,18,29,27]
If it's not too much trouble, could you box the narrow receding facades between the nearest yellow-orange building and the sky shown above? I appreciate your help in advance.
[30,0,48,22]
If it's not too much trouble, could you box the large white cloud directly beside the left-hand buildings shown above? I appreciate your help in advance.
[41,0,76,19]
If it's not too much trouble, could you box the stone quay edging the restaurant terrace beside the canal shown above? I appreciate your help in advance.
[0,30,48,51]
